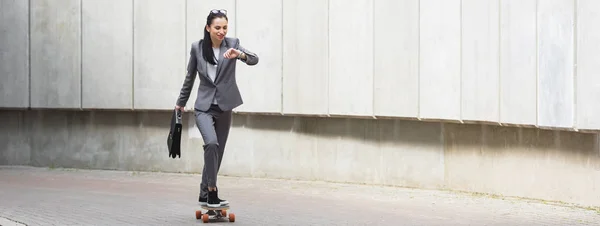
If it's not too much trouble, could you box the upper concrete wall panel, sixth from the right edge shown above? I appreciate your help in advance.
[373,0,419,118]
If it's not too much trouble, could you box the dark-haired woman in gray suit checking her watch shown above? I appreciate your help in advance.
[175,10,258,207]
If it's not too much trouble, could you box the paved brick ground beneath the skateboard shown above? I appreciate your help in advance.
[0,166,600,225]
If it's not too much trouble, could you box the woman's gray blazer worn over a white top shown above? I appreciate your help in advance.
[176,37,258,111]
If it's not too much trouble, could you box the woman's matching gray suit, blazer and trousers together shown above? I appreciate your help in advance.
[176,37,258,199]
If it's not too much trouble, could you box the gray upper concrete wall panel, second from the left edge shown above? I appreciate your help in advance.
[30,0,81,108]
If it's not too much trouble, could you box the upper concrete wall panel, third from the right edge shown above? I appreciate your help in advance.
[500,0,537,125]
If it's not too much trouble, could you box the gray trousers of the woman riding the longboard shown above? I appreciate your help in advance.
[194,104,231,198]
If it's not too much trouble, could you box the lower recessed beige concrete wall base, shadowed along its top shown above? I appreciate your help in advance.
[0,110,600,207]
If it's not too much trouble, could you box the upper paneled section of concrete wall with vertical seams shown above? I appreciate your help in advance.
[0,0,600,130]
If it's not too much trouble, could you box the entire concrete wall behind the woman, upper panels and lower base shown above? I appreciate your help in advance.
[0,0,600,206]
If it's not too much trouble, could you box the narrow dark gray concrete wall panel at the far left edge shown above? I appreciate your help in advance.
[0,0,29,108]
